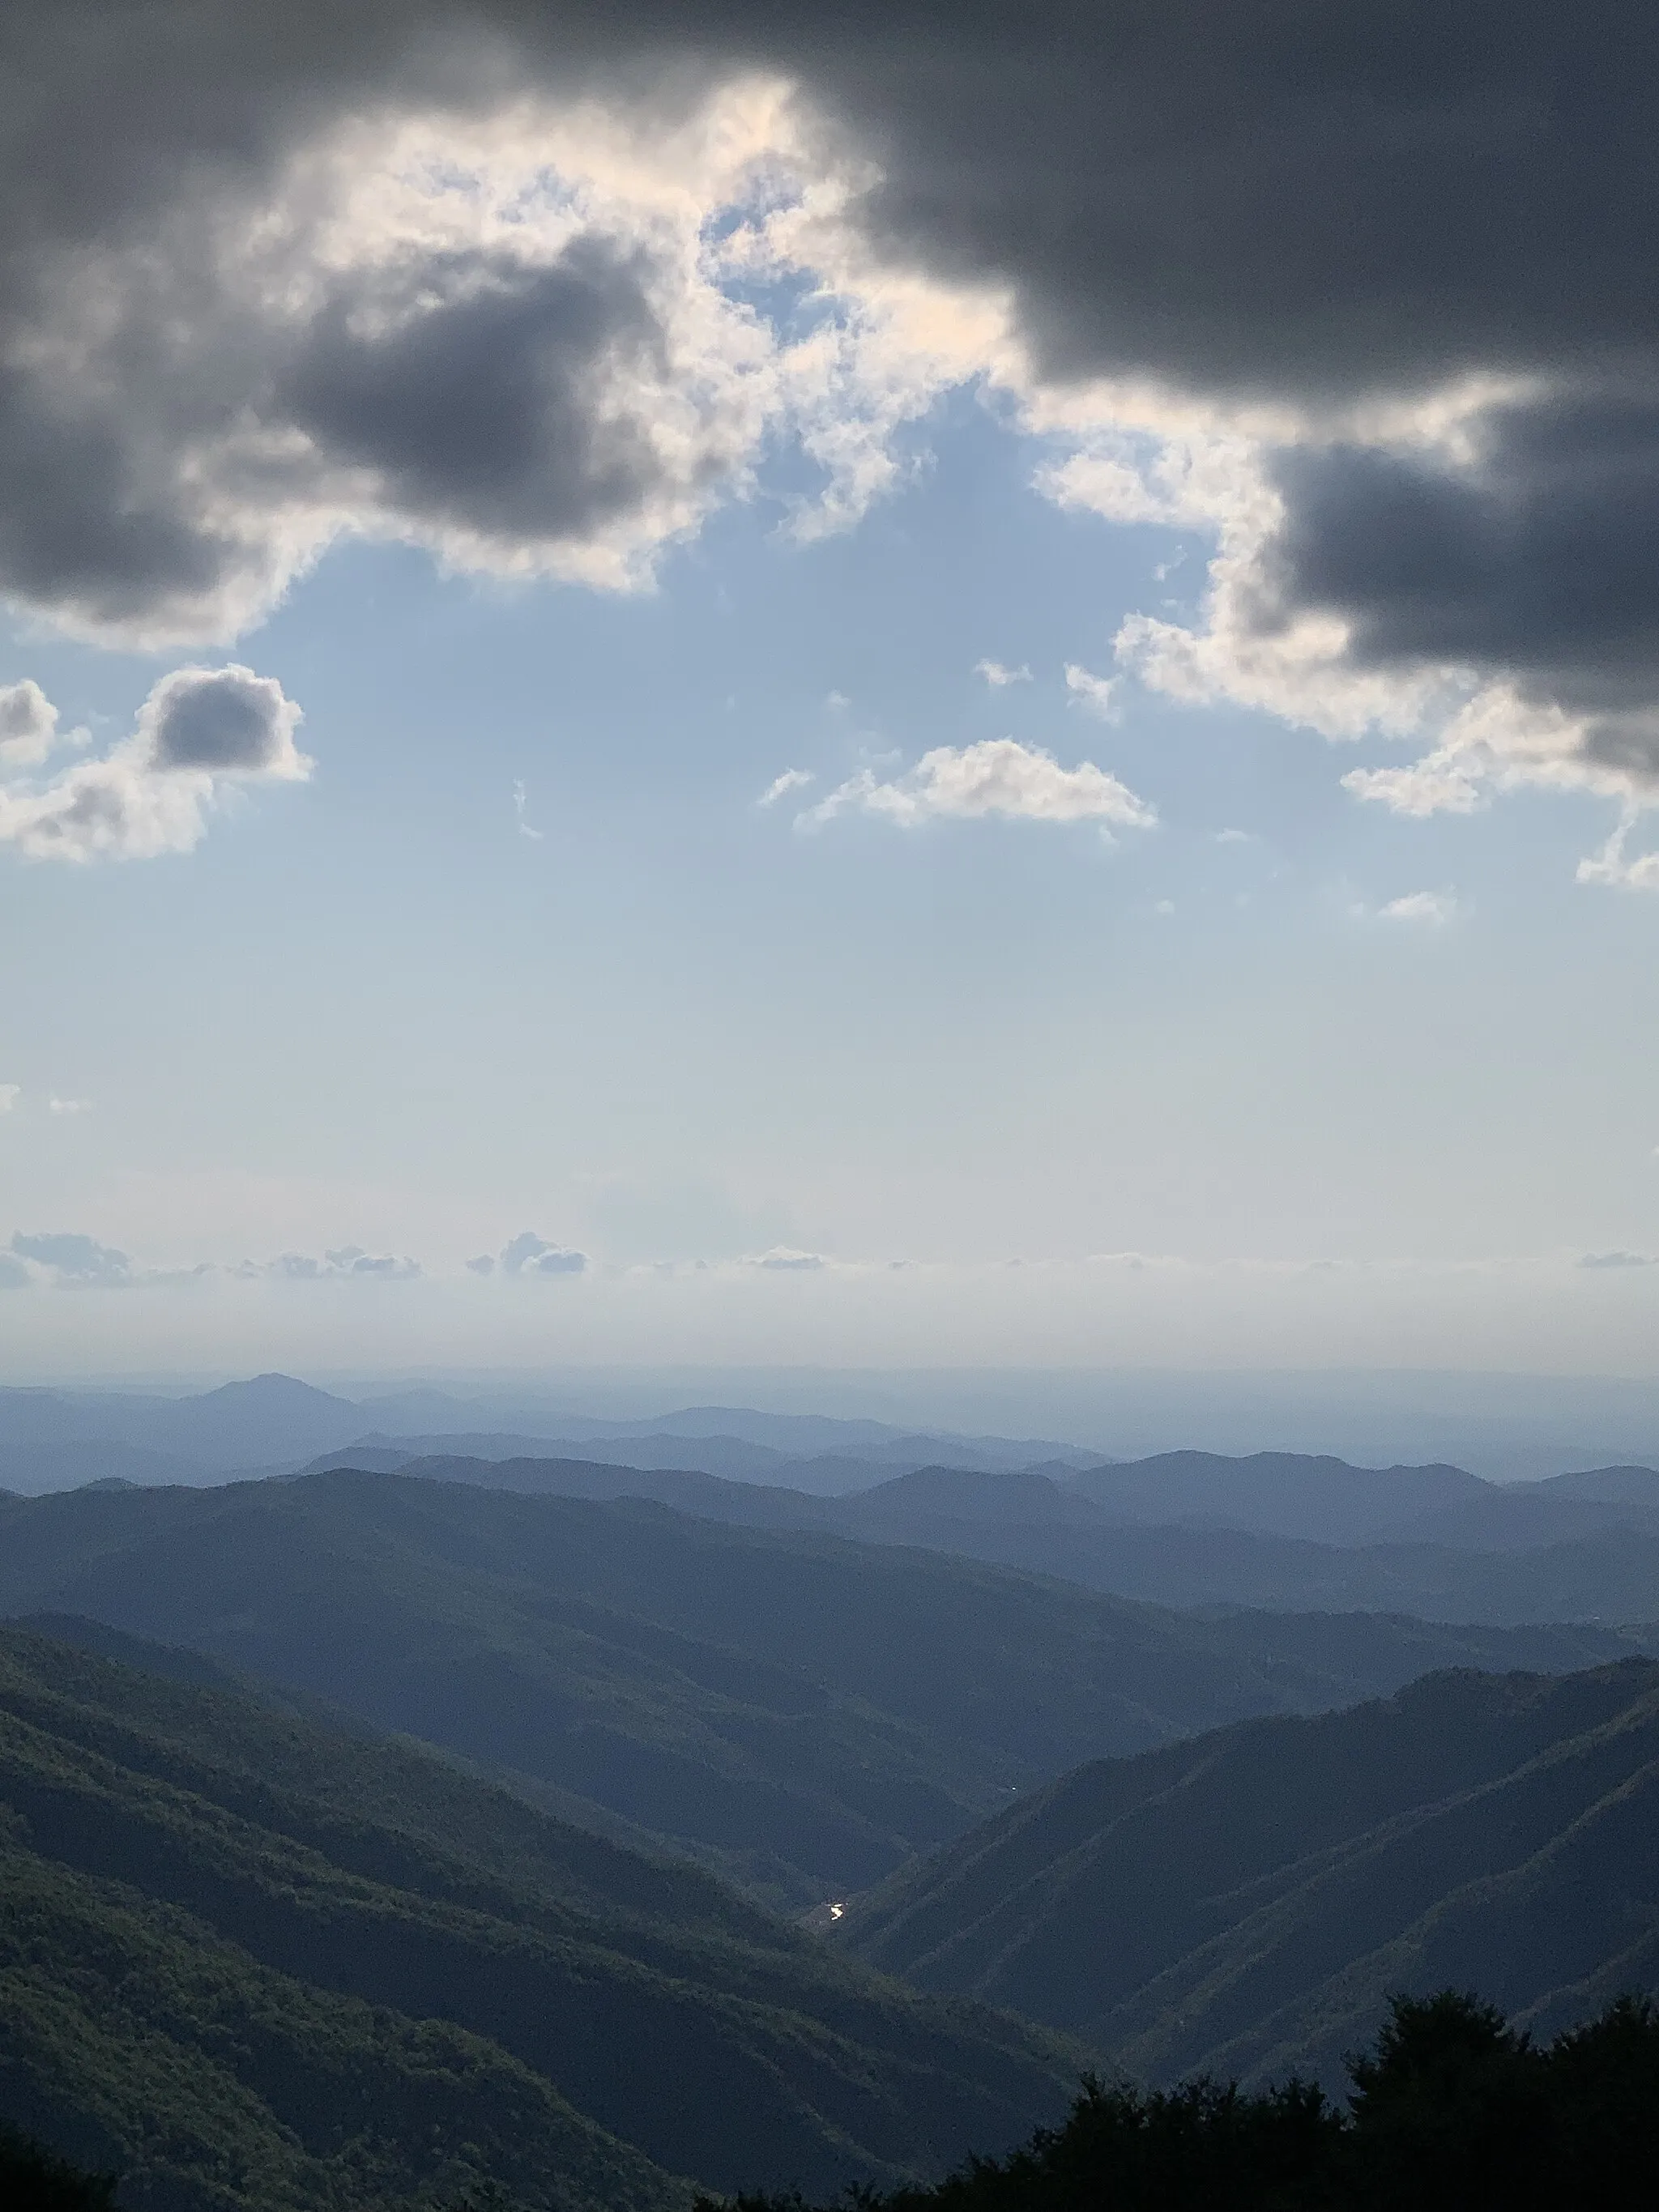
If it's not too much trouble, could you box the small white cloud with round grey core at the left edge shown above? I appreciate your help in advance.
[0,663,312,858]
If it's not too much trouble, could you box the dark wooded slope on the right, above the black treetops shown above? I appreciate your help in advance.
[838,1659,1659,2082]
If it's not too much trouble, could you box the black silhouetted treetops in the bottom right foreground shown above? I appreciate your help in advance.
[725,1991,1659,2212]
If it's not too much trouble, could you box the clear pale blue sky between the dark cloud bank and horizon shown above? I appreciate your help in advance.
[0,26,1659,1376]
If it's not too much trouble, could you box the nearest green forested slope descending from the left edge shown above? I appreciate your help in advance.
[0,1630,1077,2212]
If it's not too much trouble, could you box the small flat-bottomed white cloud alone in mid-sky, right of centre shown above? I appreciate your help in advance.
[796,736,1157,829]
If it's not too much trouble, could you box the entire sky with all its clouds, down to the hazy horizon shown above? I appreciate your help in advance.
[0,0,1659,1380]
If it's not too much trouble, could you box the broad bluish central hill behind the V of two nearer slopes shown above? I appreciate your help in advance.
[0,1473,1631,1907]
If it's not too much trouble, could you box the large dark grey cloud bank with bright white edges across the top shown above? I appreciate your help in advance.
[0,0,1659,858]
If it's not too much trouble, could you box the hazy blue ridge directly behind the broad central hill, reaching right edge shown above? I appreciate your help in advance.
[303,1444,1659,1626]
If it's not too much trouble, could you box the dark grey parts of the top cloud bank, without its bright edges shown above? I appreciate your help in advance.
[0,0,1659,761]
